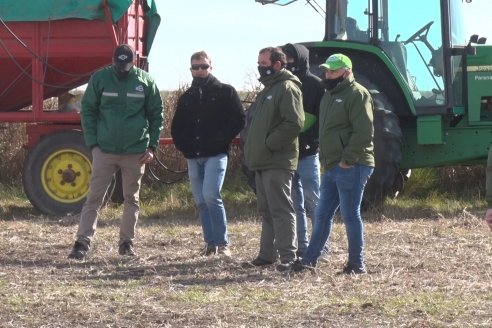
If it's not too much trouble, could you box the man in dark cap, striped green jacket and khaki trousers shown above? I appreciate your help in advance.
[68,44,164,260]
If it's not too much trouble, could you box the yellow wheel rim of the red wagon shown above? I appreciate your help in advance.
[41,149,92,204]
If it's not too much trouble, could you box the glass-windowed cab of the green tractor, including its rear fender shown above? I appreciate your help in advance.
[256,0,484,120]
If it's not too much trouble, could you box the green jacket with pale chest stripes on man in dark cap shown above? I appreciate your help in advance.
[80,67,164,154]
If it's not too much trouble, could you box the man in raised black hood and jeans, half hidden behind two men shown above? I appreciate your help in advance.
[282,43,327,257]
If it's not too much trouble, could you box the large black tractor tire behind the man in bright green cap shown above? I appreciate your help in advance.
[358,82,406,209]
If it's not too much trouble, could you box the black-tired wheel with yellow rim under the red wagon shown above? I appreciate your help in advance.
[23,130,92,215]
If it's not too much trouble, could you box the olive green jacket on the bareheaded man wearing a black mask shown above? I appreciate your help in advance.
[244,69,304,171]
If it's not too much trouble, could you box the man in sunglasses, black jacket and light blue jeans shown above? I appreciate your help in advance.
[171,51,245,256]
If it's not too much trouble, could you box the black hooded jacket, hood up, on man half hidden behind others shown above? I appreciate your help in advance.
[282,43,325,158]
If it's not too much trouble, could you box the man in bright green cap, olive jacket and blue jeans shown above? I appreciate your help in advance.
[294,54,374,274]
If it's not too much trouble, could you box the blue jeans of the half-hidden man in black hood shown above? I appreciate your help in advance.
[292,154,320,253]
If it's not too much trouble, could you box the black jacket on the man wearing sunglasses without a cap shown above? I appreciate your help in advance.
[171,74,244,158]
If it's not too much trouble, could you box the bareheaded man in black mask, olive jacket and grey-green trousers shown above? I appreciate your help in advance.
[244,47,304,271]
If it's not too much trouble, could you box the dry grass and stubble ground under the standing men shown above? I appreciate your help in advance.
[0,179,492,327]
